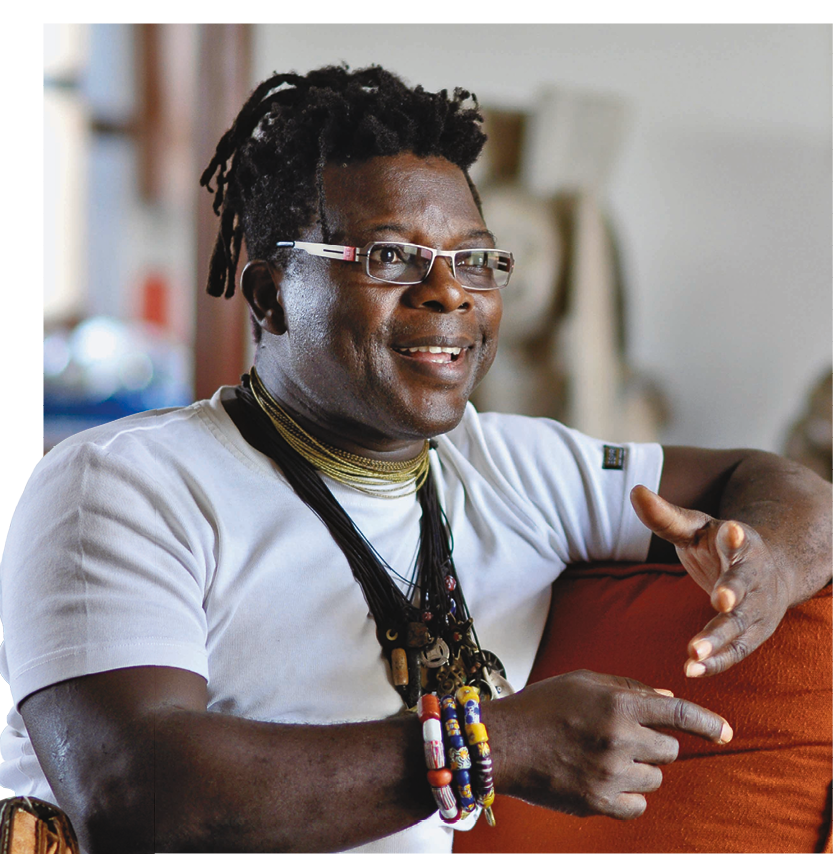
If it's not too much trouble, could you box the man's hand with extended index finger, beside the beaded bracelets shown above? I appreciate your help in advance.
[483,671,732,819]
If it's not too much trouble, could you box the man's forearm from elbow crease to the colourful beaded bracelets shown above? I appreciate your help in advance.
[153,713,435,854]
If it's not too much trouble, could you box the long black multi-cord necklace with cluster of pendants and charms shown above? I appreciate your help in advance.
[231,375,512,708]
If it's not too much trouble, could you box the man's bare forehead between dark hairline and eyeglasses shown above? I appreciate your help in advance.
[324,153,485,246]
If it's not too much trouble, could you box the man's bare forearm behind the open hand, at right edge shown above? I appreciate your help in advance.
[718,452,833,605]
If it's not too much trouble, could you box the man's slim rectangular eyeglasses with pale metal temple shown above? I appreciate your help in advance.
[277,240,515,291]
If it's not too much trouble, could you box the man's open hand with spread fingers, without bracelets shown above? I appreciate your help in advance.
[631,486,791,677]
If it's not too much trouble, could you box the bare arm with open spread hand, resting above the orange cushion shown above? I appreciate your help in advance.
[632,447,833,676]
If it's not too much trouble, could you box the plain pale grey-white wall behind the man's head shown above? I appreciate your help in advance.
[254,24,833,450]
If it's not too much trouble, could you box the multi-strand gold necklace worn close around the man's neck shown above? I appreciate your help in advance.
[250,367,430,498]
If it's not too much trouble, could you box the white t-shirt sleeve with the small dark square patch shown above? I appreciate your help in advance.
[448,413,663,564]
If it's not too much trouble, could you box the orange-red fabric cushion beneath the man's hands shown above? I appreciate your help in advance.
[454,565,833,854]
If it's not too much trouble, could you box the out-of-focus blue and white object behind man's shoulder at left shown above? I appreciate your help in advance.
[43,316,193,450]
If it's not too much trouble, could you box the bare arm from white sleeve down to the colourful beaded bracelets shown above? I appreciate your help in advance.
[21,667,435,854]
